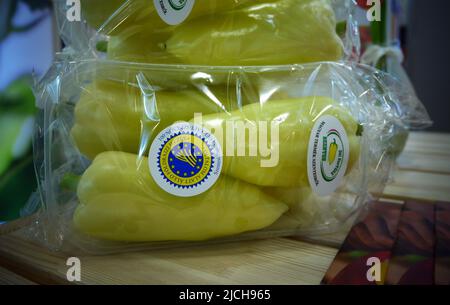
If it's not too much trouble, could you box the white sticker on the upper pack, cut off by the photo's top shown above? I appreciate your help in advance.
[153,0,195,25]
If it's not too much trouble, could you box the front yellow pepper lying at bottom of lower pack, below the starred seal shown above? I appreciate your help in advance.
[74,152,287,241]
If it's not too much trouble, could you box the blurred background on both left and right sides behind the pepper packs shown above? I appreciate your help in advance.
[0,0,450,223]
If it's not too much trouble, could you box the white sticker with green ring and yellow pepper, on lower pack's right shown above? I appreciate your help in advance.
[307,115,349,196]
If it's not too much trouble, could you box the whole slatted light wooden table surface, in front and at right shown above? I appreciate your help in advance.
[0,133,450,284]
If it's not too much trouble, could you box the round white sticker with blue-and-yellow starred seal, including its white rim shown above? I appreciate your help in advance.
[148,123,223,197]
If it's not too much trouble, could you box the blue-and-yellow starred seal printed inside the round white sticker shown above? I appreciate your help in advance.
[158,134,214,188]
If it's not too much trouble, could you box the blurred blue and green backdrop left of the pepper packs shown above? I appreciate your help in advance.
[0,0,55,223]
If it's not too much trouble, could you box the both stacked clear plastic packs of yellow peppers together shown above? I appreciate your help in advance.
[29,0,429,253]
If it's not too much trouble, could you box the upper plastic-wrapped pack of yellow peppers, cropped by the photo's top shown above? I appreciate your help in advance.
[55,0,355,66]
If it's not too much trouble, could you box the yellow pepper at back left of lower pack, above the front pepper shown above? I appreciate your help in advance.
[71,80,230,159]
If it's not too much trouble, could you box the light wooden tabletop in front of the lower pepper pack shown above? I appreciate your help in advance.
[0,233,337,284]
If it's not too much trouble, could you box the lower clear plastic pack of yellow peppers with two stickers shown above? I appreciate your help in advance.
[29,58,429,253]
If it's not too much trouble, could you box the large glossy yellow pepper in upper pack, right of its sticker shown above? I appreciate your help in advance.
[166,0,343,66]
